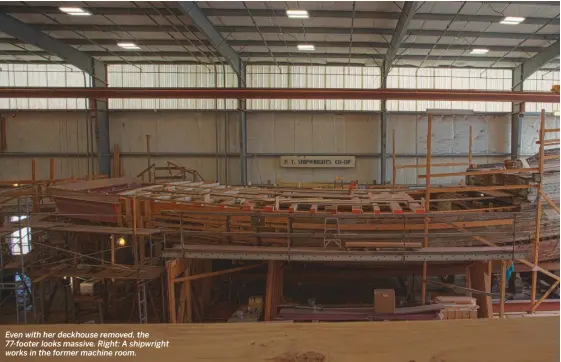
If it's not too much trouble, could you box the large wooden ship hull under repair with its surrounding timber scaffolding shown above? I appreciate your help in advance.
[0,107,560,323]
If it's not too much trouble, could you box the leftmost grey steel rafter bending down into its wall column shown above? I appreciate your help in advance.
[0,13,111,175]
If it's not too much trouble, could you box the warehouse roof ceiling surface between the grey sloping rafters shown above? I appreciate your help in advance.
[0,1,560,69]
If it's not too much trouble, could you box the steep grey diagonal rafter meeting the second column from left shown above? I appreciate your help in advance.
[178,1,244,79]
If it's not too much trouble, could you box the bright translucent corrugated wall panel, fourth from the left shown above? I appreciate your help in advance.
[387,68,512,112]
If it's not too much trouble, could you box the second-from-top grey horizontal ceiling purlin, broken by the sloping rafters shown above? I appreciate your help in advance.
[23,23,560,40]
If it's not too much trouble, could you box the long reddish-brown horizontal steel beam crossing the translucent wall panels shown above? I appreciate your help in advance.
[0,87,559,103]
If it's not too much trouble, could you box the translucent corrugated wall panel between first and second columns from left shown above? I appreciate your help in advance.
[107,64,238,110]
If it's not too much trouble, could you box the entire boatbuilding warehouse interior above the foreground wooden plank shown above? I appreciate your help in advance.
[0,1,560,358]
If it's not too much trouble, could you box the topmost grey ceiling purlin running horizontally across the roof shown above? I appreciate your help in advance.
[0,2,559,24]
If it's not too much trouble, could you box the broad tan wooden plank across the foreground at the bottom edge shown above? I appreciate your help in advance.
[0,317,559,362]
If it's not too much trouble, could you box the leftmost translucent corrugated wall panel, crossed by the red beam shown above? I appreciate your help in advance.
[0,64,90,110]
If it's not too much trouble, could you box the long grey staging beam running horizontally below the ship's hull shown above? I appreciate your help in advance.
[162,244,527,262]
